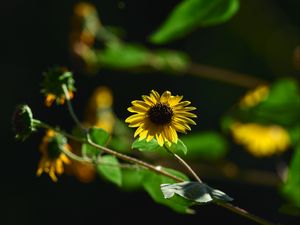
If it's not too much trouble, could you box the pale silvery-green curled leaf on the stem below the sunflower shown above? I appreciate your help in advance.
[161,181,233,204]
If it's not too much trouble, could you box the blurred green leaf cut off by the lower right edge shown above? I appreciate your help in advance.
[281,143,300,208]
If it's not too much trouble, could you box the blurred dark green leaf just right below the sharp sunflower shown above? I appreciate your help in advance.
[181,132,228,160]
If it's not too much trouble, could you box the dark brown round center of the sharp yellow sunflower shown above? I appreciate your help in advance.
[148,103,174,125]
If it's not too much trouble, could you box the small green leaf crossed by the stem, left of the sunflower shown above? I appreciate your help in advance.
[81,127,109,158]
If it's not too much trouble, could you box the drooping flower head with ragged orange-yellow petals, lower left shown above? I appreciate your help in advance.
[36,130,71,182]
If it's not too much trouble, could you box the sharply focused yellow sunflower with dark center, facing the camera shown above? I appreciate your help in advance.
[125,90,197,146]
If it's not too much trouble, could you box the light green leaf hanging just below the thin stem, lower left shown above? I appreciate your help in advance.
[97,155,122,186]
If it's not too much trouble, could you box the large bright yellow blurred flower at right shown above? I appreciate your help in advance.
[230,122,290,157]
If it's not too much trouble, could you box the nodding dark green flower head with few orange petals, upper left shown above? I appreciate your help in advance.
[42,67,75,107]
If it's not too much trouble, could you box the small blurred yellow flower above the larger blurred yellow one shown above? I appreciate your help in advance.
[239,85,269,108]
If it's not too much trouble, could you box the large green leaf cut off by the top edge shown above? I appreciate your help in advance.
[150,0,239,44]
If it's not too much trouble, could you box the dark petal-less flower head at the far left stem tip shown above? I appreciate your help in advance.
[12,105,35,141]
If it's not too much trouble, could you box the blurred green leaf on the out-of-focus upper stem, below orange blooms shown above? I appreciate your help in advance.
[97,43,149,69]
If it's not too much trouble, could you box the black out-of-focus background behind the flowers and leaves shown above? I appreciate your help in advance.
[0,0,300,225]
